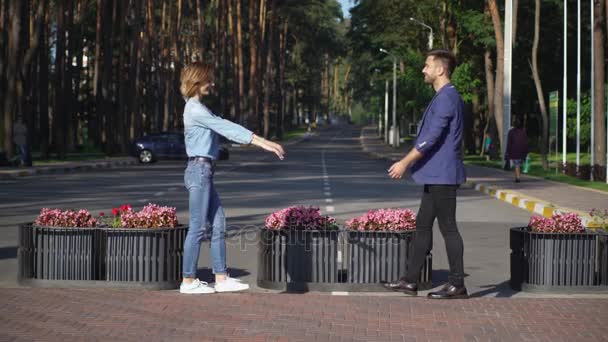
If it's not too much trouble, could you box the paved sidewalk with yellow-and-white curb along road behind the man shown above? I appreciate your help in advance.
[361,127,608,223]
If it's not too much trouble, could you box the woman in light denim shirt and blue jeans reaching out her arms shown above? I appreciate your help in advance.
[180,62,285,294]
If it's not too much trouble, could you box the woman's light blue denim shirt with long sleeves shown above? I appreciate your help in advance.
[184,97,253,159]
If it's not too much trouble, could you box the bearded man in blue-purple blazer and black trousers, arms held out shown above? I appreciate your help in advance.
[385,50,468,299]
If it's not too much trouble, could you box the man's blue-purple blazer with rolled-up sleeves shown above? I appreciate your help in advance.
[411,83,466,184]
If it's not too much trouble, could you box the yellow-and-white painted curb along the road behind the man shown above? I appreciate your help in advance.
[359,128,599,228]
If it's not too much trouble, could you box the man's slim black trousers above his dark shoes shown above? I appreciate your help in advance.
[405,184,464,287]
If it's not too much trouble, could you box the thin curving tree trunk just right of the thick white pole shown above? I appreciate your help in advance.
[532,0,549,170]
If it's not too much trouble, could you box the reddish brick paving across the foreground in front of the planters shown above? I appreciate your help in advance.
[0,288,608,342]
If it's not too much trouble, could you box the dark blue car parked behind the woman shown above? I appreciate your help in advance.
[131,132,229,164]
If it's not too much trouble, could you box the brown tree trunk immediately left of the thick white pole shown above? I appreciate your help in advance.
[487,0,509,149]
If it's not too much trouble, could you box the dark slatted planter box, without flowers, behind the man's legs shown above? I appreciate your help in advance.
[345,231,432,288]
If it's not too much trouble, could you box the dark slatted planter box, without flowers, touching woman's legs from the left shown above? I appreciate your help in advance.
[102,226,187,288]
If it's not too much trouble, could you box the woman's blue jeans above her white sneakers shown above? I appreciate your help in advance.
[182,160,226,278]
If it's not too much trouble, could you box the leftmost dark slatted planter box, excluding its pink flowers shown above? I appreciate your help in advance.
[18,223,100,280]
